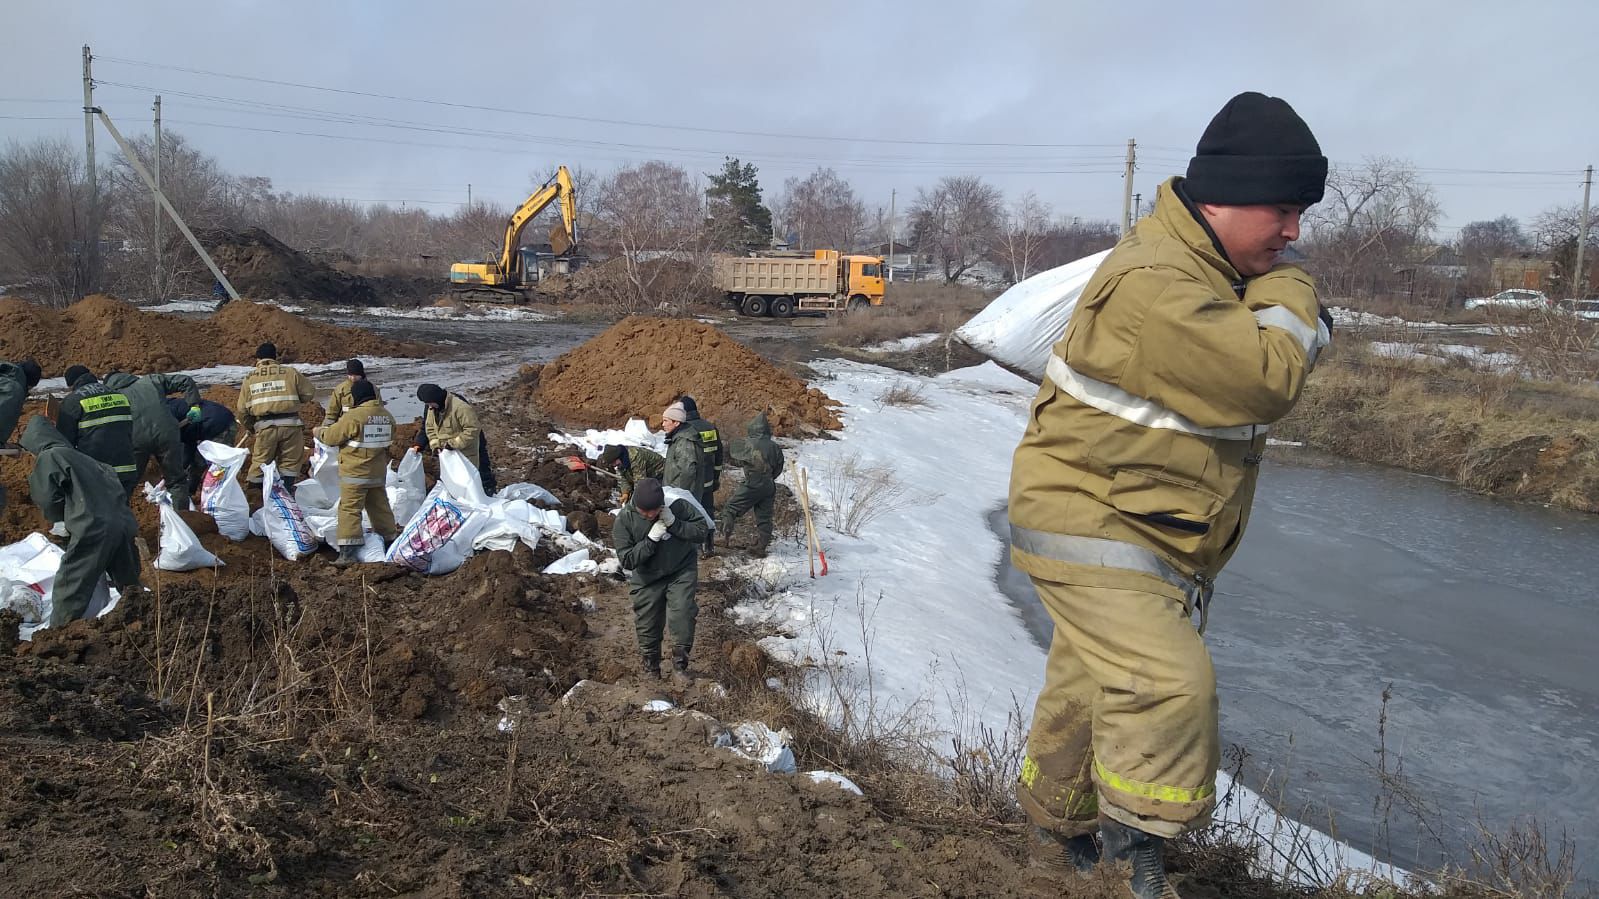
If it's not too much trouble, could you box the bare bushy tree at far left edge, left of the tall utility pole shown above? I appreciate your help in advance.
[0,139,96,304]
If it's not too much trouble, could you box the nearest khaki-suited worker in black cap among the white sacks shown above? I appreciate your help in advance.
[317,379,400,566]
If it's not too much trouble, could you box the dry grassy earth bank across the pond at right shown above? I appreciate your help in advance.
[1273,352,1599,512]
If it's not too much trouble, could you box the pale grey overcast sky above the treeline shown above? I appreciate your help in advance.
[0,0,1599,238]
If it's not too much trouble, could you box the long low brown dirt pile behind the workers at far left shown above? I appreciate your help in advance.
[0,294,429,376]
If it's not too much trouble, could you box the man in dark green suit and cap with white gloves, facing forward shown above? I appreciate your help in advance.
[611,478,710,686]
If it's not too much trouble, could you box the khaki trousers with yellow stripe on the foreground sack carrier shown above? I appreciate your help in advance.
[1017,577,1220,838]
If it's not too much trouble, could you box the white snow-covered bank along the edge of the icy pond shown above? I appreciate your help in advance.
[734,360,1407,873]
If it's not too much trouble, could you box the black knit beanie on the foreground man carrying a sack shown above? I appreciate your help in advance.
[1183,91,1327,206]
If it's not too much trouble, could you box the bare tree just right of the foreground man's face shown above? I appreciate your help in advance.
[1305,157,1442,296]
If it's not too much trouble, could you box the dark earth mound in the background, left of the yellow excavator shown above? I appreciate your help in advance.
[200,227,377,306]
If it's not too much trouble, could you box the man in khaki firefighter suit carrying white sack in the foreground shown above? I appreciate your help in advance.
[1011,93,1329,899]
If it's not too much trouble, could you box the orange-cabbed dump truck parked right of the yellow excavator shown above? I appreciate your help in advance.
[716,250,883,318]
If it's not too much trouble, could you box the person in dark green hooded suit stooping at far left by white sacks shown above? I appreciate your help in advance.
[21,416,139,627]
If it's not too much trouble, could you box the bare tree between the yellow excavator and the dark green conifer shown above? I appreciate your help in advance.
[595,160,708,309]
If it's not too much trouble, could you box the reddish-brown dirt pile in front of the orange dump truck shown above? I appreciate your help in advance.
[524,315,843,435]
